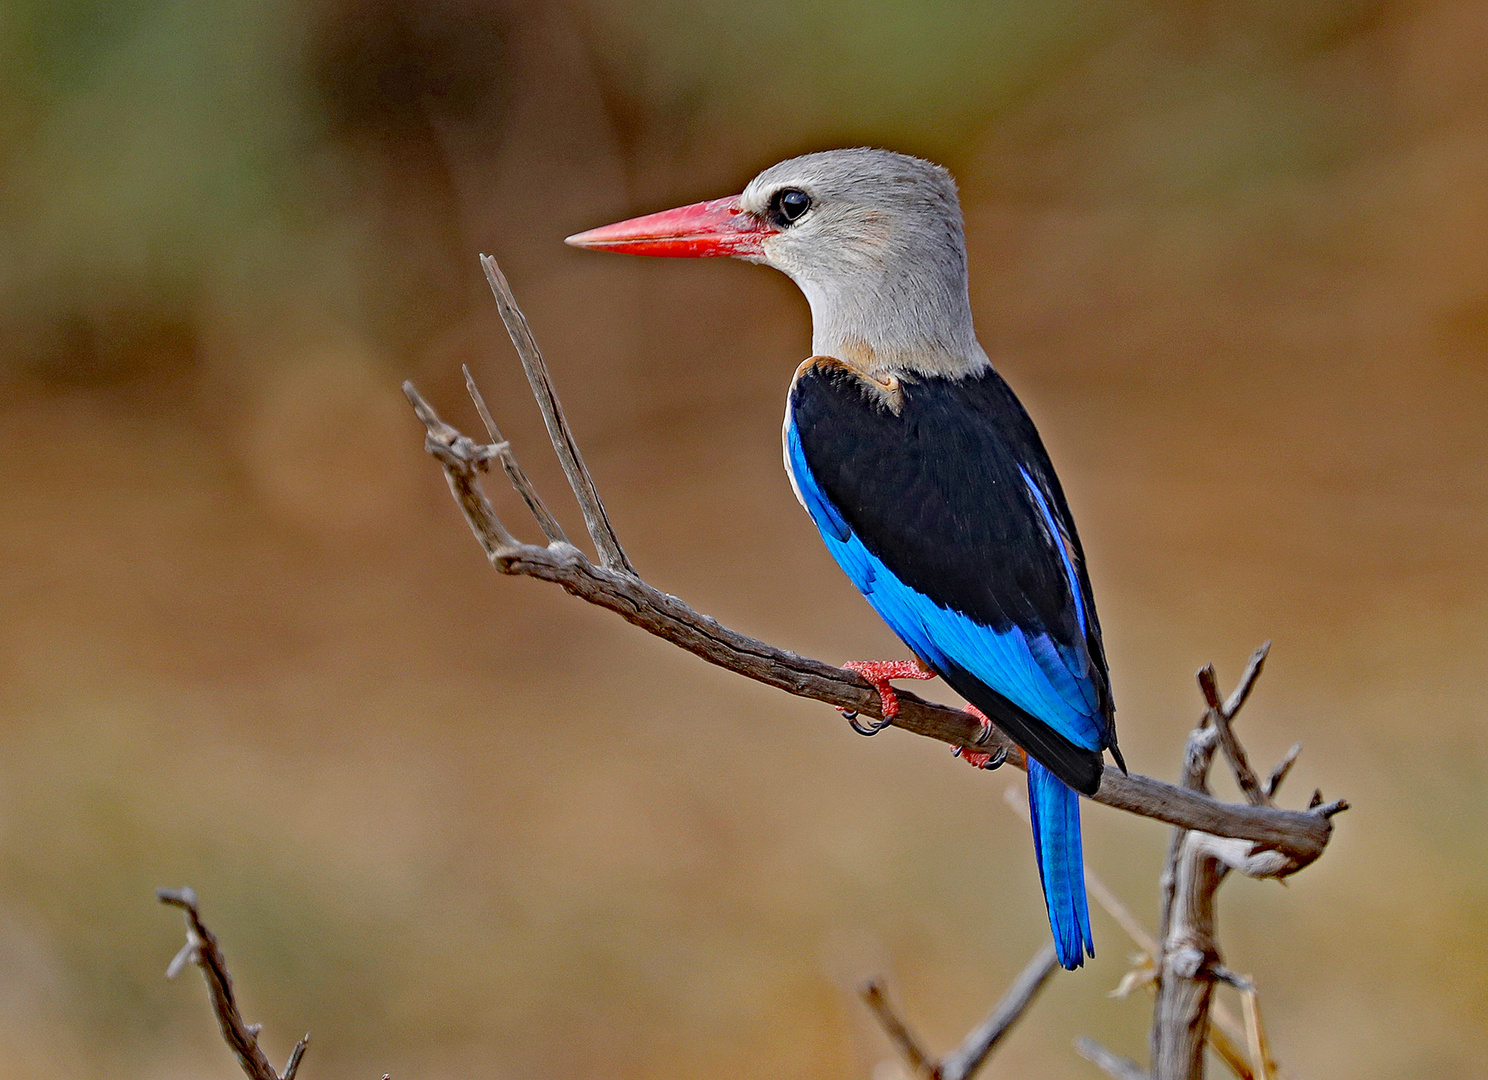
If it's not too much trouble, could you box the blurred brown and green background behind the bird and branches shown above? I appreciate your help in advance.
[0,0,1488,1080]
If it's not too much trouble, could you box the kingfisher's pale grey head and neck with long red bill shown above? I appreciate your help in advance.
[565,149,987,375]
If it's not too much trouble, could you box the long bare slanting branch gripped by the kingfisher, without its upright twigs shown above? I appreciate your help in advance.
[403,384,1332,869]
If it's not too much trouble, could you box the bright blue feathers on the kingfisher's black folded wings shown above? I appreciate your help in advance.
[786,422,1103,750]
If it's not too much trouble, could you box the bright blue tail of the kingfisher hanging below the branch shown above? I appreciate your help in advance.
[1028,757,1095,971]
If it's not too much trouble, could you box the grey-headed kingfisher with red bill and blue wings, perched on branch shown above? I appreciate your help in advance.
[565,147,1126,970]
